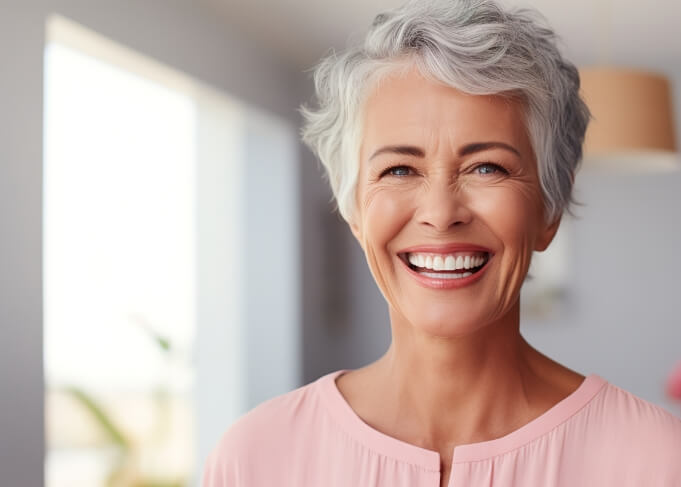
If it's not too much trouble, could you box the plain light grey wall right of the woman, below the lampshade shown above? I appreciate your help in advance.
[522,168,681,416]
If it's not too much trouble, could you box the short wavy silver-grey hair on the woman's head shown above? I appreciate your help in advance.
[301,0,590,222]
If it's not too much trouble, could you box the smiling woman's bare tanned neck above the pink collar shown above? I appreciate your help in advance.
[374,303,555,450]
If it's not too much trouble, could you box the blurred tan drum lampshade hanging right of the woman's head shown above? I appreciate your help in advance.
[580,68,677,169]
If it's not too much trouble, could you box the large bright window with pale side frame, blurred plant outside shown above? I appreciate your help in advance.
[43,16,301,487]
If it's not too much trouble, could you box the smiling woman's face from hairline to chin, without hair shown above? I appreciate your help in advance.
[351,69,558,337]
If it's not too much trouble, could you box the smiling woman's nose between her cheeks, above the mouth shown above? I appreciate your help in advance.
[417,181,473,232]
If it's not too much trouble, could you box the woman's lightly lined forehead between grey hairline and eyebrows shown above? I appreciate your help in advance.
[362,69,529,154]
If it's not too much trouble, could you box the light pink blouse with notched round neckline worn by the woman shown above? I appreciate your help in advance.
[203,370,681,487]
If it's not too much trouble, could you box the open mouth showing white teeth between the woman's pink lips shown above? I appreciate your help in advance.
[397,250,492,280]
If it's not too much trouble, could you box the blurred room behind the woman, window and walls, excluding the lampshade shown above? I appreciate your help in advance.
[0,0,681,487]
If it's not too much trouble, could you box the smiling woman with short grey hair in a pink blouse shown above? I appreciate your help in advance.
[204,0,681,487]
